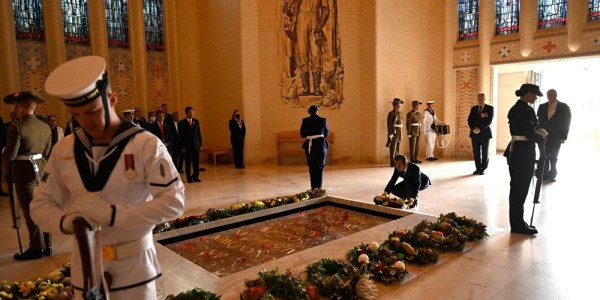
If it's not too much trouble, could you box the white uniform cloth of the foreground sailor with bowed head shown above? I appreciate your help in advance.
[31,131,184,296]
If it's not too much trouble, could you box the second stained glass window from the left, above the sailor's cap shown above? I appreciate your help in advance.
[62,0,90,44]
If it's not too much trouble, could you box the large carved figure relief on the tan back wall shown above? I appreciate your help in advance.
[279,0,344,108]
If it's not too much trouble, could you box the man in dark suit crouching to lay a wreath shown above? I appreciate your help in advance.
[384,154,431,208]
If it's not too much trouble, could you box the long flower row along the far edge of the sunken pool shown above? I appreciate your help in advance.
[153,189,329,233]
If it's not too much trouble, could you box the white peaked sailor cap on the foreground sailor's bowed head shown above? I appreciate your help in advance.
[45,56,107,106]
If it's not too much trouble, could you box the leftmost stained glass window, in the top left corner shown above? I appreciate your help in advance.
[13,0,44,41]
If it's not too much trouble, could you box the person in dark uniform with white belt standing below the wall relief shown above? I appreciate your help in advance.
[300,105,329,189]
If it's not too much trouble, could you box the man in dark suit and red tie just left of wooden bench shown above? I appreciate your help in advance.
[177,106,202,183]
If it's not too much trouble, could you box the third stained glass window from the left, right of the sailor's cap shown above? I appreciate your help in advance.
[104,0,129,48]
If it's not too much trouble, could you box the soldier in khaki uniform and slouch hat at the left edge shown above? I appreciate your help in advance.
[2,92,52,260]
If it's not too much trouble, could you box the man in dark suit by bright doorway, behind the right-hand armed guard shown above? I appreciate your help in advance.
[537,89,571,182]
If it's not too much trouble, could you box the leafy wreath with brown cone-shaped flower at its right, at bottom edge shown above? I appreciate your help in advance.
[306,258,378,300]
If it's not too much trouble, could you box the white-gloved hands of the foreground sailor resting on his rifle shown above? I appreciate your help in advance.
[67,193,116,227]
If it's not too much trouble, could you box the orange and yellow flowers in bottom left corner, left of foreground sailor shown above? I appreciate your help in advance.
[0,265,73,300]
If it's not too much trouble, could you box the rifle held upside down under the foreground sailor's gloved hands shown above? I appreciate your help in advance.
[73,217,109,300]
